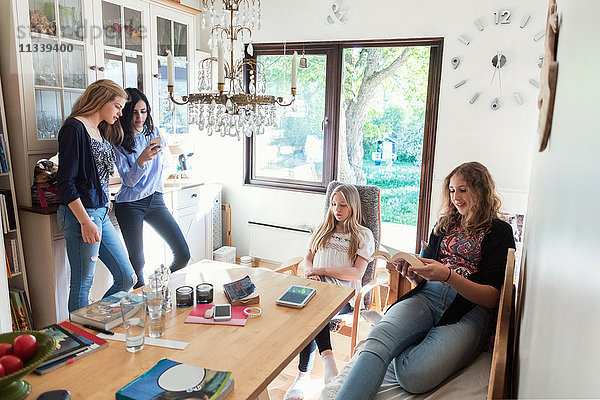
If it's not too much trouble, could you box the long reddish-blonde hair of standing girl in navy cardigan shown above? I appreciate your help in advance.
[67,79,127,143]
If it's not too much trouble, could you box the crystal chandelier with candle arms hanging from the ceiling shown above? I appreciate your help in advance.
[167,0,297,140]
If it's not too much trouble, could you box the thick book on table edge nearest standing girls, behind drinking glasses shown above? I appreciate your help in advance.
[69,291,144,331]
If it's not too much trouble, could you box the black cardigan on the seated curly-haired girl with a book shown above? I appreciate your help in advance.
[398,219,515,326]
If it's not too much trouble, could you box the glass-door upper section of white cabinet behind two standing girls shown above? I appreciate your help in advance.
[0,0,196,206]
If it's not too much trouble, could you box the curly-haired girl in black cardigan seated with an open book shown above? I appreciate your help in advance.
[336,162,515,400]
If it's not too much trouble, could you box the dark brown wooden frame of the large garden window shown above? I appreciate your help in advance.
[244,37,444,252]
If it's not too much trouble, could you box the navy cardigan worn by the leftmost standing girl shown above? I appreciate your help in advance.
[57,118,108,208]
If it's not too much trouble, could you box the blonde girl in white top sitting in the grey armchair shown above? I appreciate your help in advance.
[284,185,375,400]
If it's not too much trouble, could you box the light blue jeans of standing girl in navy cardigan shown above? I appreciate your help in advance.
[56,205,135,312]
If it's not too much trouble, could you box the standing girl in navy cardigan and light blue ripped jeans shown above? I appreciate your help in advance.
[57,79,135,311]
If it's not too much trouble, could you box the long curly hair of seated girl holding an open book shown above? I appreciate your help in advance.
[435,161,501,235]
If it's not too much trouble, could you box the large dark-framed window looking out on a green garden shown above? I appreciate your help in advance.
[245,38,443,251]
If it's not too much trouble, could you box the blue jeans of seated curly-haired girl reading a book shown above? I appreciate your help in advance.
[336,282,490,400]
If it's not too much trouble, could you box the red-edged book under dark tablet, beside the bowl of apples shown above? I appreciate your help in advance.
[35,321,108,375]
